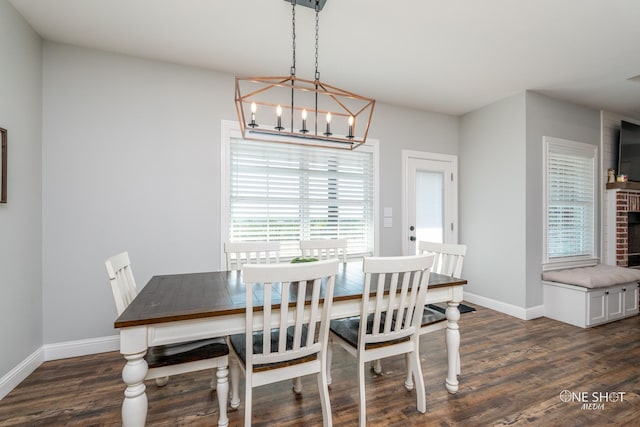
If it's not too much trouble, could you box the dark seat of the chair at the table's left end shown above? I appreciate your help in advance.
[145,337,229,368]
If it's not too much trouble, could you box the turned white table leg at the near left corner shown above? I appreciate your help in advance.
[122,350,148,427]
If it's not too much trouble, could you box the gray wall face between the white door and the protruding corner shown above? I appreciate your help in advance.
[459,93,526,307]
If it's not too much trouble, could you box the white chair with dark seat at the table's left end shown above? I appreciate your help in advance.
[105,252,238,427]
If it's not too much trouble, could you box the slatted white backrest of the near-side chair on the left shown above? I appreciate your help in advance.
[242,260,339,371]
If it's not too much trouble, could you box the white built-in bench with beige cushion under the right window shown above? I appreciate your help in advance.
[542,264,640,328]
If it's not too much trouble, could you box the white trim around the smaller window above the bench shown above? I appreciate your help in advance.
[542,136,600,271]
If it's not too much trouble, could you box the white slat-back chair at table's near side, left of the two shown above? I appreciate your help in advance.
[229,260,338,427]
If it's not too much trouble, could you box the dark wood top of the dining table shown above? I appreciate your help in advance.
[114,261,467,328]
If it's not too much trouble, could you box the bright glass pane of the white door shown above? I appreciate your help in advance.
[416,170,444,243]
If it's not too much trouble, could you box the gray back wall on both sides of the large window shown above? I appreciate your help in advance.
[42,42,458,344]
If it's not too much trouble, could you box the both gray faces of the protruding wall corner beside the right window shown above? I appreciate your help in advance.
[459,92,600,310]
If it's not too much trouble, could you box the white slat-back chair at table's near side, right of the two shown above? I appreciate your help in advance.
[327,255,434,427]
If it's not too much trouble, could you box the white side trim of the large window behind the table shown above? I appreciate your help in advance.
[219,120,380,268]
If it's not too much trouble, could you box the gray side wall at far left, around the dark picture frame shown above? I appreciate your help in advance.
[0,1,42,378]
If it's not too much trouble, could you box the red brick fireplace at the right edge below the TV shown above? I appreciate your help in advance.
[616,190,640,268]
